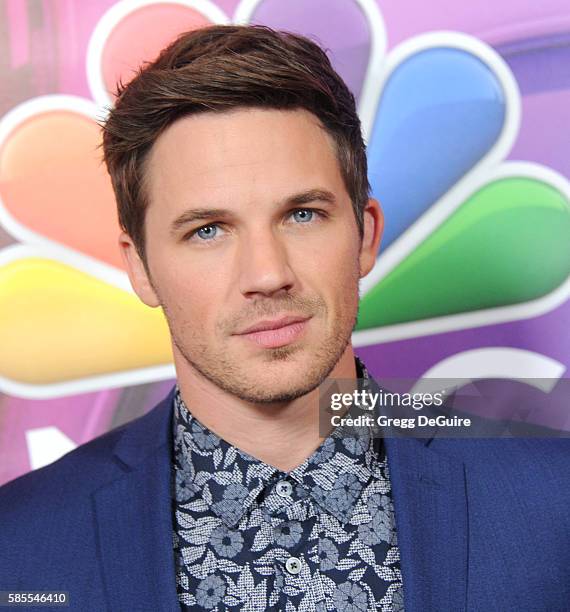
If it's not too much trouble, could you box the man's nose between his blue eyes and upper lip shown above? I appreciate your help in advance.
[239,229,295,297]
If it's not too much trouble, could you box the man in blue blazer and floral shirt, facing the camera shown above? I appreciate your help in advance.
[0,26,570,612]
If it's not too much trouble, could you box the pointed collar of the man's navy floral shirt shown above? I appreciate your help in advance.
[173,356,379,527]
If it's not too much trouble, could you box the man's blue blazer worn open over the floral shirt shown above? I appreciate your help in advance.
[0,389,570,612]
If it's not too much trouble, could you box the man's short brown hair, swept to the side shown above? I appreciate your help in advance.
[102,25,370,265]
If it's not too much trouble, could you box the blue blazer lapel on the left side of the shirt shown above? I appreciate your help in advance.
[93,389,180,612]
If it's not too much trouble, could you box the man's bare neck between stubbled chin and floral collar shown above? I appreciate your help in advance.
[175,345,356,472]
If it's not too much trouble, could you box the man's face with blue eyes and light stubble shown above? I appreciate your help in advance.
[122,109,381,403]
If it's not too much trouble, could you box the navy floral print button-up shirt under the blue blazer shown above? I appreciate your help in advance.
[173,357,403,612]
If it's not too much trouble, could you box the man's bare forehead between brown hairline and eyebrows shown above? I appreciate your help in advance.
[145,108,343,202]
